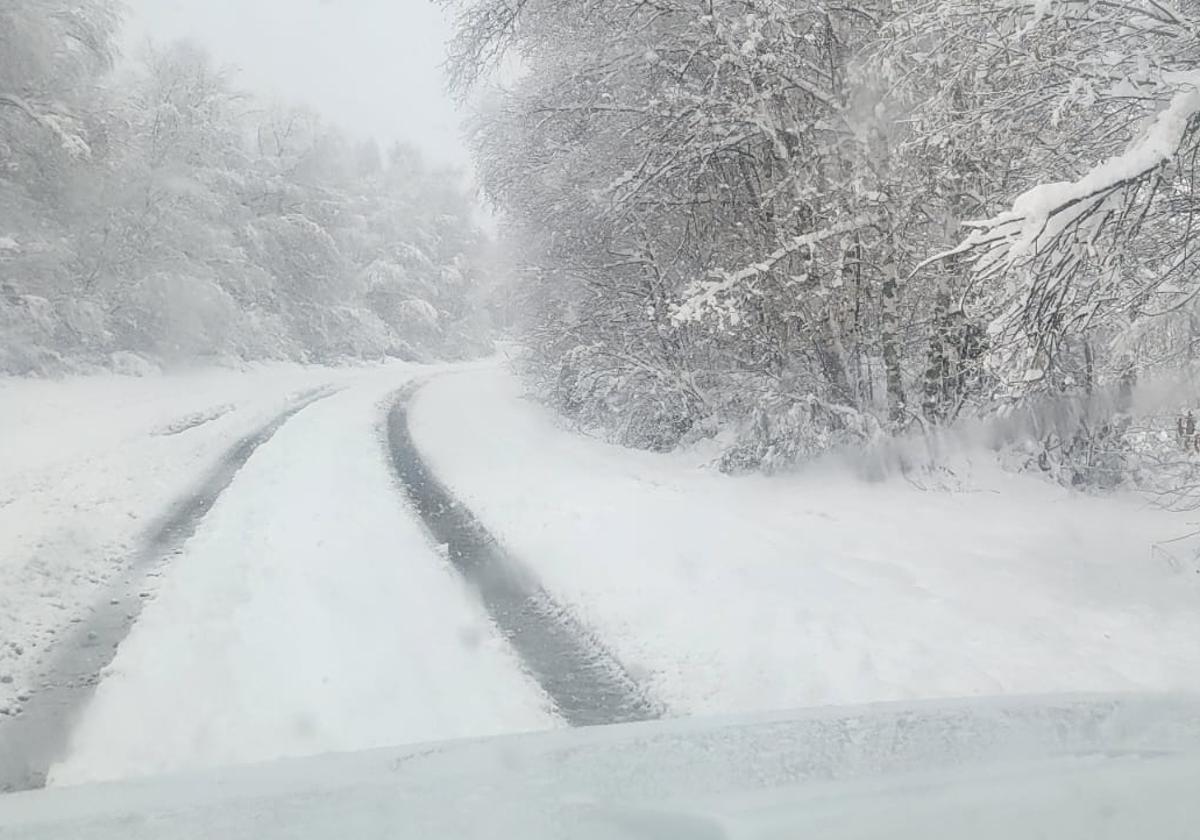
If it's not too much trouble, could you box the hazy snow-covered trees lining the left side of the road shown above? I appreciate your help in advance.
[0,29,487,372]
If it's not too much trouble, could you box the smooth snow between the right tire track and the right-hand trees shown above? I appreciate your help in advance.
[410,370,1200,713]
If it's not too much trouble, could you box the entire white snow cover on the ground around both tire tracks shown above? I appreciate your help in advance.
[9,366,1200,784]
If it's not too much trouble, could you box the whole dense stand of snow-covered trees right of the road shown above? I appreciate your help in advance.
[448,0,1200,482]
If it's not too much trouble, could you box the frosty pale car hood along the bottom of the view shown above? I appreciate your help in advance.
[0,697,1200,840]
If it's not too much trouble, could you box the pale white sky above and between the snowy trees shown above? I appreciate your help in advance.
[125,0,468,166]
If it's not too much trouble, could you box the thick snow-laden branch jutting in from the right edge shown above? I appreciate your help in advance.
[960,72,1200,275]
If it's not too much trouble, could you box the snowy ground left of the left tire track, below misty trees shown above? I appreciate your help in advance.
[0,365,384,714]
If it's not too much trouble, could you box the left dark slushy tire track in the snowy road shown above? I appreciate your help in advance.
[0,386,337,793]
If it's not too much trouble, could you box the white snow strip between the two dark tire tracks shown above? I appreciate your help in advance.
[52,374,556,784]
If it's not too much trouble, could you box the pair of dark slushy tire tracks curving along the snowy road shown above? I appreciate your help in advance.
[0,382,664,794]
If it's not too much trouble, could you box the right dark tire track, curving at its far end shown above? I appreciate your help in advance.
[388,383,664,726]
